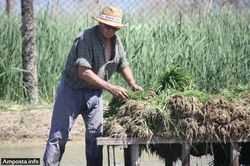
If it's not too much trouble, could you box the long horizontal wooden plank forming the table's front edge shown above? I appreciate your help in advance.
[97,137,250,146]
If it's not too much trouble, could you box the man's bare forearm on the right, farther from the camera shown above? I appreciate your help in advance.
[121,65,143,91]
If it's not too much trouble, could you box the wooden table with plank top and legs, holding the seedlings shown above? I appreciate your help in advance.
[97,137,250,166]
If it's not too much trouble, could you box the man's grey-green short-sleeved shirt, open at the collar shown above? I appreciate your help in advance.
[62,25,128,89]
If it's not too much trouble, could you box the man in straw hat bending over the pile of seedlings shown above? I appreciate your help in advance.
[44,6,142,166]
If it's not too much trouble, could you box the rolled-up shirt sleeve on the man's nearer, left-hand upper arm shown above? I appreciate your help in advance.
[76,37,93,68]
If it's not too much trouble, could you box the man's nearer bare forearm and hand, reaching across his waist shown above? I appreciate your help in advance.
[78,66,128,99]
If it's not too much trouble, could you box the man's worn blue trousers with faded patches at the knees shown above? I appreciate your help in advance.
[43,80,103,166]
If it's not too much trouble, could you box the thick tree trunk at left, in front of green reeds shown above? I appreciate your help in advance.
[21,0,38,103]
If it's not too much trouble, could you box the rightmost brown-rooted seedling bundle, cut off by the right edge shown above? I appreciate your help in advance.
[204,97,250,140]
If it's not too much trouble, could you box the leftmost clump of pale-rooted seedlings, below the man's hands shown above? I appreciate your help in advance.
[105,96,172,139]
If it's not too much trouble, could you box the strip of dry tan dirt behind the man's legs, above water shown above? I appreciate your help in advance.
[0,103,84,143]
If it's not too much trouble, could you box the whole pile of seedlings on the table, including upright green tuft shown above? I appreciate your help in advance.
[104,68,250,142]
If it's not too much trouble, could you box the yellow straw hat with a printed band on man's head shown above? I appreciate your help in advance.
[94,6,126,28]
